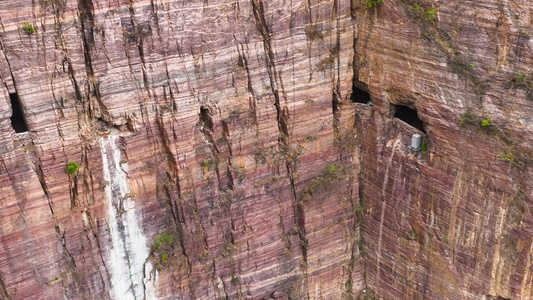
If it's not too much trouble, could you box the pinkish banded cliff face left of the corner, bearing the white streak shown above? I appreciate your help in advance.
[0,0,363,299]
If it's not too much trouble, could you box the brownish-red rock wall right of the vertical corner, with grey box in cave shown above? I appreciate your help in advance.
[355,1,533,299]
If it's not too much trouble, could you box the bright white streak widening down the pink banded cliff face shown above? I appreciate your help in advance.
[100,135,157,300]
